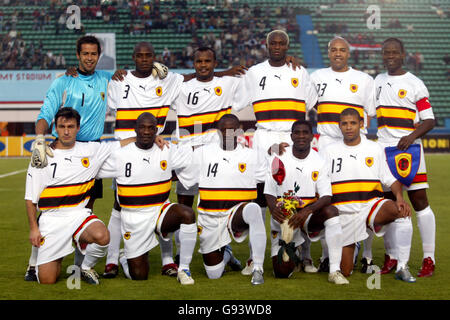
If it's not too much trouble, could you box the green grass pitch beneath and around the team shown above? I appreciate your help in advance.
[0,155,450,300]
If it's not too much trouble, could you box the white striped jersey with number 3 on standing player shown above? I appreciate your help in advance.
[107,71,184,140]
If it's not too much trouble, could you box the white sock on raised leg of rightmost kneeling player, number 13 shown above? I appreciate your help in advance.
[392,218,413,271]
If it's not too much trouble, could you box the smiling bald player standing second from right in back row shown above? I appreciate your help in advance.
[311,37,376,273]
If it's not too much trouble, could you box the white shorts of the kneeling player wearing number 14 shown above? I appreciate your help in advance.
[197,203,248,254]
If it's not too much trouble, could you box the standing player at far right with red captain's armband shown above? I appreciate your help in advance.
[375,38,436,277]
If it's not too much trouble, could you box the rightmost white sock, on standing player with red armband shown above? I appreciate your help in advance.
[416,206,436,262]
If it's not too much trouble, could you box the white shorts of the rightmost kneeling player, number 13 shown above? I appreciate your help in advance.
[339,198,391,247]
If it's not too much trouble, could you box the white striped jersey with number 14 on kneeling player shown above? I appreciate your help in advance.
[185,143,267,215]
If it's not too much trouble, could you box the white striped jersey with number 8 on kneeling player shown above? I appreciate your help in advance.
[98,143,192,211]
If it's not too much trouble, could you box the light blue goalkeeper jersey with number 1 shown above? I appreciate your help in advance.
[37,71,112,141]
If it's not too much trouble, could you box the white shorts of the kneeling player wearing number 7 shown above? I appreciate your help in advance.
[36,209,101,266]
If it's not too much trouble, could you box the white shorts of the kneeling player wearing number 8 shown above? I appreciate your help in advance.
[120,202,174,259]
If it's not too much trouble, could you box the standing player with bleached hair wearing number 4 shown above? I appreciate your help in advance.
[236,30,317,274]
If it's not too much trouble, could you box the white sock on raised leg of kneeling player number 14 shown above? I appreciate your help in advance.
[242,203,267,269]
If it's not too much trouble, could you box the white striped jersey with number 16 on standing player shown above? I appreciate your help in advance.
[172,77,241,146]
